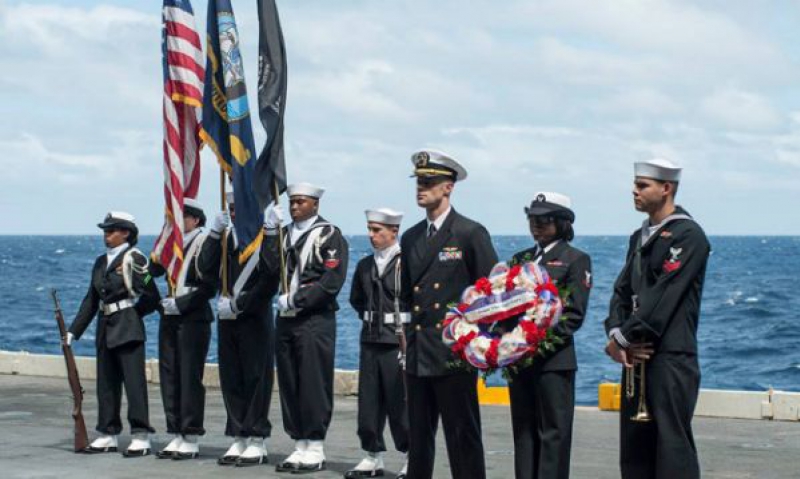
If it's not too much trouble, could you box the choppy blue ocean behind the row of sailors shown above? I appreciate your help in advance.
[0,234,800,405]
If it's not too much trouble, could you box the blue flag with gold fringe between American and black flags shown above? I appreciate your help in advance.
[200,0,264,263]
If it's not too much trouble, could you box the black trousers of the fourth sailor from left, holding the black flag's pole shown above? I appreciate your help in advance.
[275,311,336,441]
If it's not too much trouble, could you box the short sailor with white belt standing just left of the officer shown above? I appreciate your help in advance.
[344,208,410,479]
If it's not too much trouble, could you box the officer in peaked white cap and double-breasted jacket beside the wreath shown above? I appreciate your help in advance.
[400,150,497,479]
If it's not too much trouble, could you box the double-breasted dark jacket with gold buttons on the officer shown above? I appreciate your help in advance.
[400,209,497,376]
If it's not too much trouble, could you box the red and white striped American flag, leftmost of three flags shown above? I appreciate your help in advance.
[152,0,205,286]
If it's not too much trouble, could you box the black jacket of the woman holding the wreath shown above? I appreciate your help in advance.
[511,241,592,371]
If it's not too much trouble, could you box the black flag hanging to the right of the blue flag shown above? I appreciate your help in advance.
[254,0,287,208]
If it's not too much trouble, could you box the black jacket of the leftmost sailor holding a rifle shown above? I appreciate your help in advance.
[69,247,158,349]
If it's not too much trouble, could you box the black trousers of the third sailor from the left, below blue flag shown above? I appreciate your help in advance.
[217,311,275,437]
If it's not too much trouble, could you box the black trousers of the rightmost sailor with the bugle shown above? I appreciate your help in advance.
[620,353,700,479]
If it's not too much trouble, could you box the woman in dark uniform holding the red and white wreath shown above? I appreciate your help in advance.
[508,192,592,479]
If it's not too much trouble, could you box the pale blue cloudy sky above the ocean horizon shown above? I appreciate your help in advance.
[0,0,800,235]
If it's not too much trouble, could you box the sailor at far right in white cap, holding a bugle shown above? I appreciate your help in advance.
[605,159,711,479]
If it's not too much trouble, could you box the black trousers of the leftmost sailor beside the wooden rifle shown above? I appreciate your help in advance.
[96,341,155,435]
